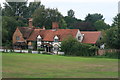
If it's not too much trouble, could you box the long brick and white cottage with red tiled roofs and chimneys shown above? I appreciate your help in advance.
[13,18,101,53]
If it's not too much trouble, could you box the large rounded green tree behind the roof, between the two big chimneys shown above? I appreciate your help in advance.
[32,7,65,29]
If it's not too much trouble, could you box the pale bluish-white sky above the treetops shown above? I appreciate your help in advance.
[0,0,119,25]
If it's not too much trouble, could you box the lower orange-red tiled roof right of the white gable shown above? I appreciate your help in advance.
[81,31,101,44]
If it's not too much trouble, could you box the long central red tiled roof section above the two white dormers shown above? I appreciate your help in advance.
[28,29,78,41]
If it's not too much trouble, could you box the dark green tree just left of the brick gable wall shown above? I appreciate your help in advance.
[2,16,18,44]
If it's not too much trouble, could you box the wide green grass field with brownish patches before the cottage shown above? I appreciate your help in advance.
[2,53,118,78]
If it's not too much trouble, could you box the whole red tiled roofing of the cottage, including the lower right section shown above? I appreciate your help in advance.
[18,27,101,44]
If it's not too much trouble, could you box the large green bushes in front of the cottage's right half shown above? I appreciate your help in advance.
[61,36,97,56]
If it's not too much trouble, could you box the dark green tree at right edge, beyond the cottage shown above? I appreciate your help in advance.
[104,14,120,49]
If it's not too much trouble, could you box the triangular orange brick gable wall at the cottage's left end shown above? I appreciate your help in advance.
[13,28,26,44]
